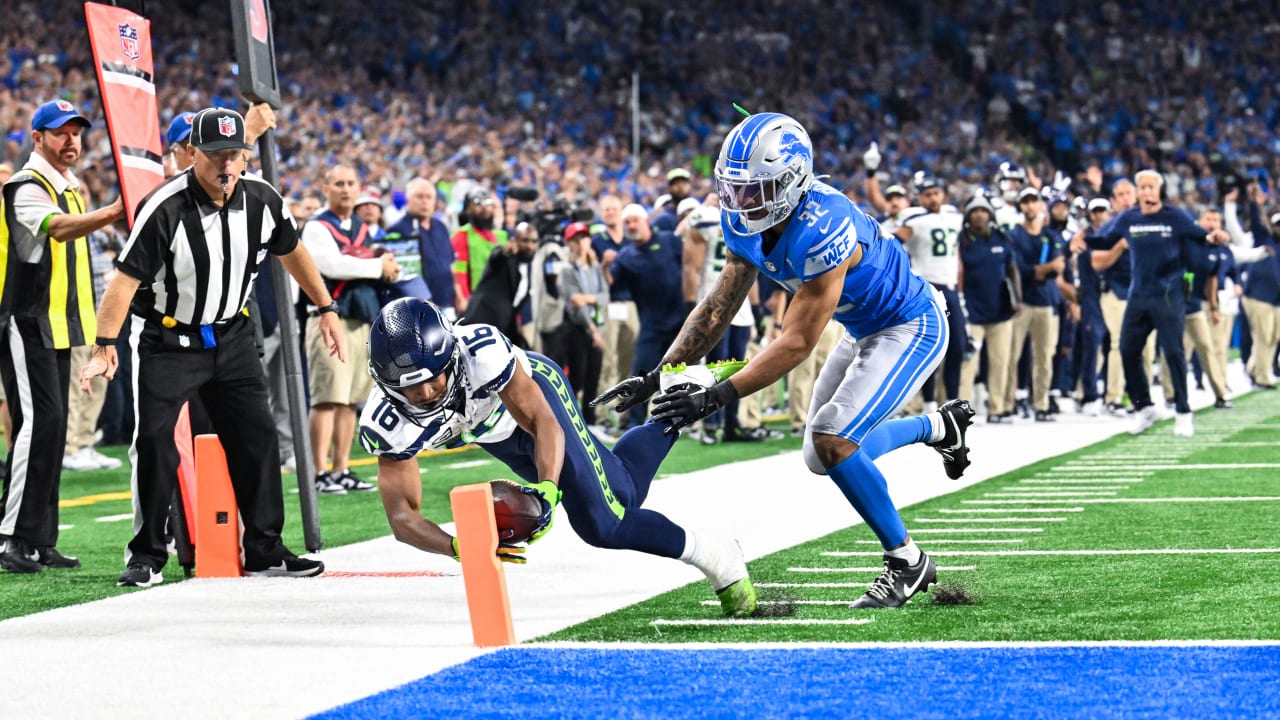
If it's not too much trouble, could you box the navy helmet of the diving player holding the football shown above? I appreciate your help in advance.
[369,297,466,423]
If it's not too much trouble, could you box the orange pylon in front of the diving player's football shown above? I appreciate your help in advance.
[449,483,516,647]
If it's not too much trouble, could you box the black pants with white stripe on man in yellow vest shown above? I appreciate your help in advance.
[0,316,72,547]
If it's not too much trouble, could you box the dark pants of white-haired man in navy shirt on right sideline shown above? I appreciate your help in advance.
[1120,291,1192,413]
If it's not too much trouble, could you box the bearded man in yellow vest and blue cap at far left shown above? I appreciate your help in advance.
[0,100,124,573]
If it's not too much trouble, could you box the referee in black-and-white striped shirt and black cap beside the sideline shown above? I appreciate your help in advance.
[81,108,342,587]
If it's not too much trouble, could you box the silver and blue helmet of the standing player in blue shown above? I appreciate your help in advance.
[716,113,813,234]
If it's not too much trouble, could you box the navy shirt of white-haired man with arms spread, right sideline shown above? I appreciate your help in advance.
[1098,206,1208,299]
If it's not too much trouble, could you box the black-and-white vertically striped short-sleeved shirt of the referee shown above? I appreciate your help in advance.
[115,170,298,325]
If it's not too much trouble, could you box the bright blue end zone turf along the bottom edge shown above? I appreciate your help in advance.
[315,646,1280,720]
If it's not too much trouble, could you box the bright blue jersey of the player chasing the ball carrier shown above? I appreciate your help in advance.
[721,182,933,337]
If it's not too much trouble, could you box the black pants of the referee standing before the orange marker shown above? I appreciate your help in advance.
[124,315,293,571]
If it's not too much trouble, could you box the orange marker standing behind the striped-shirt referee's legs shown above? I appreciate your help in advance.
[195,436,241,578]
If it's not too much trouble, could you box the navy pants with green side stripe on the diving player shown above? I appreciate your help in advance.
[483,352,685,557]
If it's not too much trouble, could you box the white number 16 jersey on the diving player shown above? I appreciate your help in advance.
[360,324,529,460]
